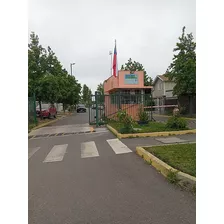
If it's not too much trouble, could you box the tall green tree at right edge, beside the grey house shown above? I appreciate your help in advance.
[166,27,196,115]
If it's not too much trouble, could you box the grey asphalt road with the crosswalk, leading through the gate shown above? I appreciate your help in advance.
[28,114,196,224]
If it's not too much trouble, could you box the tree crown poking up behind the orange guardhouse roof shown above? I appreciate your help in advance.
[121,58,152,86]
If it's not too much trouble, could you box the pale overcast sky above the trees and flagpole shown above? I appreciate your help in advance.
[28,0,196,91]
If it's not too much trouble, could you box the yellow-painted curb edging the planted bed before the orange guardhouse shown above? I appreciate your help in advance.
[107,125,196,139]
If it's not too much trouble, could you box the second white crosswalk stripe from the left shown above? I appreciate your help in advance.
[43,144,68,163]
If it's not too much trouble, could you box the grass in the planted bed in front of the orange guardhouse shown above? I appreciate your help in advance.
[109,121,188,133]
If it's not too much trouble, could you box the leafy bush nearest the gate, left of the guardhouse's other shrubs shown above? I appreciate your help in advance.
[117,110,134,133]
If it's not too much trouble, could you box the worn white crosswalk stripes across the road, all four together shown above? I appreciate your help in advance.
[28,139,132,163]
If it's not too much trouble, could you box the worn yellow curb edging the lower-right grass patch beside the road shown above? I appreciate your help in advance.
[136,146,196,191]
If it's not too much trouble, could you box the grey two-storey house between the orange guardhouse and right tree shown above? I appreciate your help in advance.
[152,75,177,112]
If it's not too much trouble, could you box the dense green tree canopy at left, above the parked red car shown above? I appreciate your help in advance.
[28,32,81,109]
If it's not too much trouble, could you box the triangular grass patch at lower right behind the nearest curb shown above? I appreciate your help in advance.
[144,143,196,177]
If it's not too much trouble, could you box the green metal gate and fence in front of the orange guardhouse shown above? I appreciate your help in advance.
[89,92,155,126]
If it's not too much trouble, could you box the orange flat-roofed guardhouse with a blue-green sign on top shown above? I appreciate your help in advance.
[103,70,152,119]
